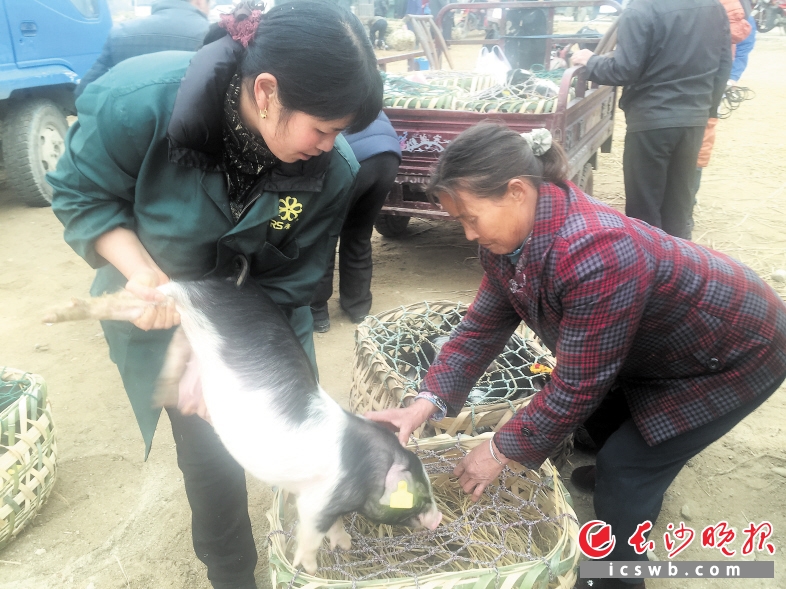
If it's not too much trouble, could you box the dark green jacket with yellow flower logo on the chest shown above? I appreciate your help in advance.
[48,45,358,456]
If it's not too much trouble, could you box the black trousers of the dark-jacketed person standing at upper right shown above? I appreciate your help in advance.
[622,127,704,239]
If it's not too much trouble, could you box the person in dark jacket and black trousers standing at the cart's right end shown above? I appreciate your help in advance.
[572,0,732,239]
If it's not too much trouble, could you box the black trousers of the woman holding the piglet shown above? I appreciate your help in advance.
[167,409,257,589]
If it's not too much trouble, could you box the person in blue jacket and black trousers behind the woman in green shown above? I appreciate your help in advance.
[311,112,401,333]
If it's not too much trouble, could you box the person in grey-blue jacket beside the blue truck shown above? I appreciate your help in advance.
[75,0,210,96]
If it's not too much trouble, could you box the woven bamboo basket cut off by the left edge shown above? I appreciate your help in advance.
[0,368,57,549]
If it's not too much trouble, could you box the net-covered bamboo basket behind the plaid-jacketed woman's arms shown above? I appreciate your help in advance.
[349,301,572,467]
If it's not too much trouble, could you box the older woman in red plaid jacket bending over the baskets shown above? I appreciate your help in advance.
[367,123,786,589]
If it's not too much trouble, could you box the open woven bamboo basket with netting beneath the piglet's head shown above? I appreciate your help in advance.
[267,433,579,589]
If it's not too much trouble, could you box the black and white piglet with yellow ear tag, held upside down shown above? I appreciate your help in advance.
[47,280,442,573]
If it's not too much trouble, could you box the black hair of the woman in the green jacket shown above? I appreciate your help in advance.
[205,0,382,132]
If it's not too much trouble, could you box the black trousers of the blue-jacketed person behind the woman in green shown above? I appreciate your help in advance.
[311,152,399,321]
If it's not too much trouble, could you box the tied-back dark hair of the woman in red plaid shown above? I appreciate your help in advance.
[428,121,568,198]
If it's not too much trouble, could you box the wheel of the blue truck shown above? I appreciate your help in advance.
[3,98,68,207]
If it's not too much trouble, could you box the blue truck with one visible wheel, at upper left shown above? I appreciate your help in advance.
[0,0,112,207]
